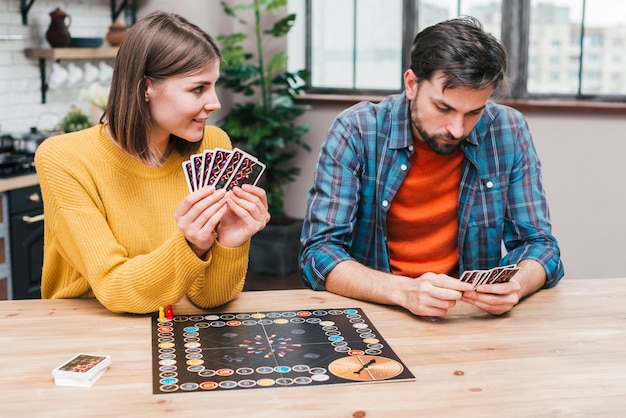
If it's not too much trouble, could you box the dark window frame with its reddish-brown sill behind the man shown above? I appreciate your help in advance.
[305,0,626,104]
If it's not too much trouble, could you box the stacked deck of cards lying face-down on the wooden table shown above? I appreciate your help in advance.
[52,353,111,387]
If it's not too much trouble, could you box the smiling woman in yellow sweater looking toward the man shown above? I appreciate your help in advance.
[35,12,270,313]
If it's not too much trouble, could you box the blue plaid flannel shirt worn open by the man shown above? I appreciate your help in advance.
[300,93,564,290]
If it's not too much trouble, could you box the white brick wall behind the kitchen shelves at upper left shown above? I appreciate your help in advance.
[0,0,119,134]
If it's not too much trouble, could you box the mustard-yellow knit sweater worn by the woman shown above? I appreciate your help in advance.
[35,125,250,313]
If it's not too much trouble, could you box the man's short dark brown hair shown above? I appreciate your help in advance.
[411,16,508,94]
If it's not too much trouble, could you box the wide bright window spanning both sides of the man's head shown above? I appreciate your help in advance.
[289,0,626,101]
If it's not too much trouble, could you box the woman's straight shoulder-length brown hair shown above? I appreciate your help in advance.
[100,12,222,165]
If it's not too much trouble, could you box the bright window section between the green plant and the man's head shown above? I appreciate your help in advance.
[288,0,404,92]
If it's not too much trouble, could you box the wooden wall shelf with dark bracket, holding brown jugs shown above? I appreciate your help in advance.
[24,47,118,103]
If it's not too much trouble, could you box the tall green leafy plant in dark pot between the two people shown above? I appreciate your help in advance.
[217,0,310,275]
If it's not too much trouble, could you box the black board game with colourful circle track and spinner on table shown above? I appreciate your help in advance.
[152,308,415,394]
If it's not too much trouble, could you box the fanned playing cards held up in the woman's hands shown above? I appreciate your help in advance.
[183,148,265,193]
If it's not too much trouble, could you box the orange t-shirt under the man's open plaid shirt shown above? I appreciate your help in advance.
[387,141,464,277]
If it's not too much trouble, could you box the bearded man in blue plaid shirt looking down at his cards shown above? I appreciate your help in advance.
[300,18,563,316]
